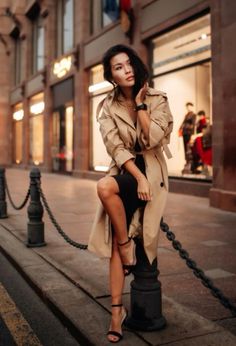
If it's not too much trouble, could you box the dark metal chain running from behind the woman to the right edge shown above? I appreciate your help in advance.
[161,221,236,316]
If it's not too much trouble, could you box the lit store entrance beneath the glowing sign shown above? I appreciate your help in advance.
[51,106,73,173]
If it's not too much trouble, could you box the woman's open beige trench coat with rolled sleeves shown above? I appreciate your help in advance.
[88,88,173,263]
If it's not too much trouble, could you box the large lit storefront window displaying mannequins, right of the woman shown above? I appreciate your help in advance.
[153,15,212,179]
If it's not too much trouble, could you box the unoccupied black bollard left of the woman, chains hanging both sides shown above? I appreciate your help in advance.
[26,168,46,247]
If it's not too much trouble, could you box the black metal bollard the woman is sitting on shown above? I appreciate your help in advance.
[125,239,166,331]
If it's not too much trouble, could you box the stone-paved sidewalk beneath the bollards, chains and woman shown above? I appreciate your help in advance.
[0,169,236,346]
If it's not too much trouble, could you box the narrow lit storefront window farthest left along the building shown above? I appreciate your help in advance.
[13,103,24,164]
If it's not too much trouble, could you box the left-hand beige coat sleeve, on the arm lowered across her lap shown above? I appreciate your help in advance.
[97,101,135,168]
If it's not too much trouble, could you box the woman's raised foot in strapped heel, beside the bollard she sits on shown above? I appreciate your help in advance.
[118,238,136,276]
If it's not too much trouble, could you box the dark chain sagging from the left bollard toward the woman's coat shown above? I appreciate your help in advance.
[36,180,88,250]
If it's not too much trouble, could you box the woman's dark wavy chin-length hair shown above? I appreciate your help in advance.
[102,44,149,98]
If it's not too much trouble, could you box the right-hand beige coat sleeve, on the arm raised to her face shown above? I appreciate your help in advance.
[142,93,173,149]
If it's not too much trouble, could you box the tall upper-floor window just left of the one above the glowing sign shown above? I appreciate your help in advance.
[32,16,45,73]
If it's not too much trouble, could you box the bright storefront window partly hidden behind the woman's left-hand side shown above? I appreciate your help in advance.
[89,65,112,171]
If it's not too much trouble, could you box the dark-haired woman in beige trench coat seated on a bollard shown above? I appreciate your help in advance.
[89,45,173,342]
